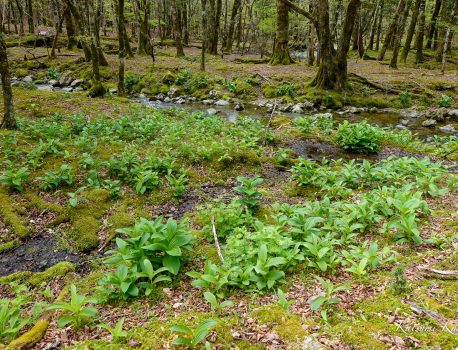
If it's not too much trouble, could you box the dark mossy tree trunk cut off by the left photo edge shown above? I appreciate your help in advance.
[0,34,17,130]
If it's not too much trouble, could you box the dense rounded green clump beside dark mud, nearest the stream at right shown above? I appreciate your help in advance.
[336,121,381,153]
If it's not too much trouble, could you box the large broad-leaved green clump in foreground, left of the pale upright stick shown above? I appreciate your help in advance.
[100,217,193,299]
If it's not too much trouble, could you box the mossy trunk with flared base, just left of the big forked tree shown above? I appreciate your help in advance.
[269,0,294,65]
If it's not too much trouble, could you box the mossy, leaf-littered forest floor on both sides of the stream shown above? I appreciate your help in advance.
[0,48,458,349]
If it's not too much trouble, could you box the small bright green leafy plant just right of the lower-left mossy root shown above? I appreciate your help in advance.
[48,284,98,329]
